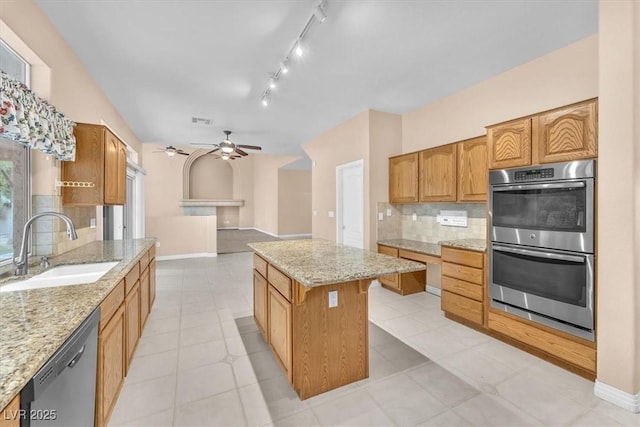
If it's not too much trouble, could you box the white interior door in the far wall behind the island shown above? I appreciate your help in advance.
[336,160,364,249]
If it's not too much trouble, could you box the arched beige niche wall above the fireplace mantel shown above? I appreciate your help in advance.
[189,156,233,200]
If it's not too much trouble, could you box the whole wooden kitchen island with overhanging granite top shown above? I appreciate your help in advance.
[249,239,425,399]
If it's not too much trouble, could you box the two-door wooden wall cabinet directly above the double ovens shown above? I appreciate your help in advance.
[487,99,598,169]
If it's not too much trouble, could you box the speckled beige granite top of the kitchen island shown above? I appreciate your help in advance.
[249,239,426,287]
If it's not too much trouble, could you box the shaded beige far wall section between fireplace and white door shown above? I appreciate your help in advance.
[278,169,311,236]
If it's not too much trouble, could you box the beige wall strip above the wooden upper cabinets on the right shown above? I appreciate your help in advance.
[402,35,598,153]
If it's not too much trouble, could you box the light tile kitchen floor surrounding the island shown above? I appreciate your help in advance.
[109,253,640,427]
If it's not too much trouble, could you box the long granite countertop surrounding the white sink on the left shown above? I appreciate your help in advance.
[0,239,155,410]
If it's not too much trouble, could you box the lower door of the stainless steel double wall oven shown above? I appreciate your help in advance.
[489,243,594,340]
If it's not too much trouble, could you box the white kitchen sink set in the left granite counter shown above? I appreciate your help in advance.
[0,261,118,292]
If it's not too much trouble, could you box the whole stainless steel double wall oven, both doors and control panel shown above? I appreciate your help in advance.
[489,160,595,341]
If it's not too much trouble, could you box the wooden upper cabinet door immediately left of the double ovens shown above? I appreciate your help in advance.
[458,136,489,202]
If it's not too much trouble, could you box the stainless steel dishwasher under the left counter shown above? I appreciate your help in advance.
[20,307,100,427]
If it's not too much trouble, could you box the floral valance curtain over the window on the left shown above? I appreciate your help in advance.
[0,70,76,160]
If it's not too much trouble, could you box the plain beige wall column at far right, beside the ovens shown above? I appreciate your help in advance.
[596,1,640,405]
